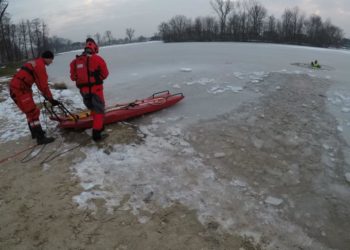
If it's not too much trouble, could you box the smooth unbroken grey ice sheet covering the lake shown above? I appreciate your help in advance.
[48,42,350,131]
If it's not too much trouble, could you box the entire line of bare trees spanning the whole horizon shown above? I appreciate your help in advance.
[0,0,350,64]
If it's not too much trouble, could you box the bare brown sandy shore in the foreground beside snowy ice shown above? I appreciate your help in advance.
[0,124,261,250]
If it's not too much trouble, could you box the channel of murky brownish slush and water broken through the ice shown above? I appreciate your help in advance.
[189,74,350,250]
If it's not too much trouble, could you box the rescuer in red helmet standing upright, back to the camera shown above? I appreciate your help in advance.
[70,38,109,141]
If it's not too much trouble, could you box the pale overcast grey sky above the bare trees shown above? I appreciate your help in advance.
[7,0,350,41]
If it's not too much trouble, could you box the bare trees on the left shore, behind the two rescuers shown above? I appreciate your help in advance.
[0,0,148,64]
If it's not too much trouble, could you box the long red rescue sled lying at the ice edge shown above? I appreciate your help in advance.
[44,90,184,129]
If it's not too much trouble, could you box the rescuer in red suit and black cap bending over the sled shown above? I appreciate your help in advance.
[9,51,59,145]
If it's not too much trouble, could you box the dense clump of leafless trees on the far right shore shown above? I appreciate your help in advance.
[158,0,346,47]
